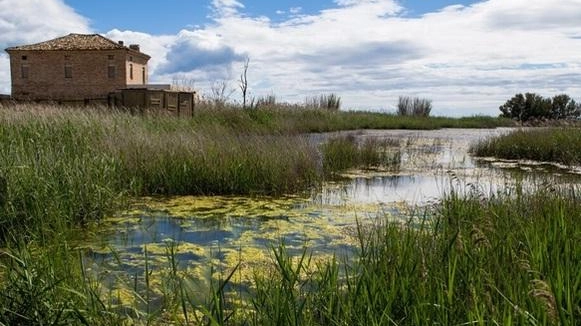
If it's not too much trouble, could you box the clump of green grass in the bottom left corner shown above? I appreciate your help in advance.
[0,242,127,325]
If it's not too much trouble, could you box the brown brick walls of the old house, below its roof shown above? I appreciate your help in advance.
[10,49,147,101]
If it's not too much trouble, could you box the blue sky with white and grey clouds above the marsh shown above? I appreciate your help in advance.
[0,0,581,116]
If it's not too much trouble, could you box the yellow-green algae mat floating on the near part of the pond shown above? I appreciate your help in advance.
[79,192,406,306]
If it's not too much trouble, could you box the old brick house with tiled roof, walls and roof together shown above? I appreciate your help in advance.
[6,34,150,101]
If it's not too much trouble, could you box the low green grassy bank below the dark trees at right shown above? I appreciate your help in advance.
[471,127,581,165]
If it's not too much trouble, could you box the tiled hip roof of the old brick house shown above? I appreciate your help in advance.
[6,34,145,55]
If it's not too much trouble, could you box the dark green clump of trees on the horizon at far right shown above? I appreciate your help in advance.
[499,93,581,121]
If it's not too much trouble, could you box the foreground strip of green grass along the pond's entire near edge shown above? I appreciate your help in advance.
[0,185,581,325]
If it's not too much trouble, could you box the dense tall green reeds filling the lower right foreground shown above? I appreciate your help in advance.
[245,190,581,325]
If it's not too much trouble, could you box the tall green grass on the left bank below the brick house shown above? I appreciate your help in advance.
[0,107,322,240]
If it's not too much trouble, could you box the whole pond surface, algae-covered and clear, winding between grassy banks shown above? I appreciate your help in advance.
[83,128,578,302]
